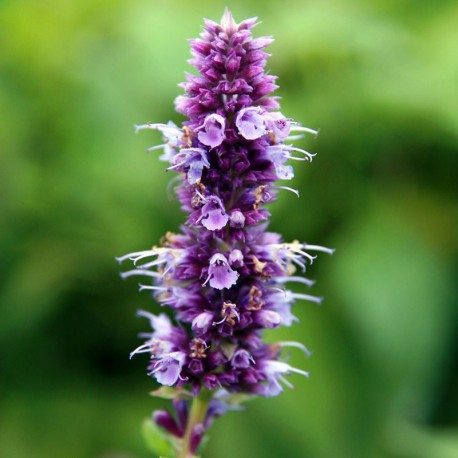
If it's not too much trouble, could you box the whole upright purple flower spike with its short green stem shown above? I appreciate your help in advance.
[119,10,333,458]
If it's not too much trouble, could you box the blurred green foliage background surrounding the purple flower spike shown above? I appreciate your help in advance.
[0,0,458,458]
